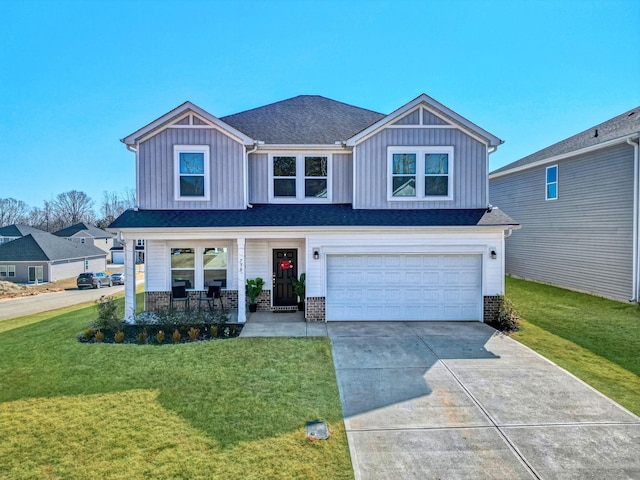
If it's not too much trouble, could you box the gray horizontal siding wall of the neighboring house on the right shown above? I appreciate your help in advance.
[490,144,633,301]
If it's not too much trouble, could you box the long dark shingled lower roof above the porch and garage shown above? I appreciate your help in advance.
[108,204,518,229]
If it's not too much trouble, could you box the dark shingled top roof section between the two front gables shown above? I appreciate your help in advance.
[220,95,385,145]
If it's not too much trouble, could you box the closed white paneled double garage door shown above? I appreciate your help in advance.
[326,255,482,321]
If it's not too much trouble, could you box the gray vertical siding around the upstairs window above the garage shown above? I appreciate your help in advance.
[353,127,484,210]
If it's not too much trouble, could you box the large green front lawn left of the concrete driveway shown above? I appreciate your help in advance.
[0,300,353,479]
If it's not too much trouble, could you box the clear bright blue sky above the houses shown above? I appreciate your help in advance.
[0,0,640,207]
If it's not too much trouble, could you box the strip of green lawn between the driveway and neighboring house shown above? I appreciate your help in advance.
[506,277,640,415]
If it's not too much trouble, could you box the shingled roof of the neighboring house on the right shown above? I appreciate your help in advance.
[491,106,640,175]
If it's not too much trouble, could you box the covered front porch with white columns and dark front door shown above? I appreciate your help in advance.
[122,235,309,323]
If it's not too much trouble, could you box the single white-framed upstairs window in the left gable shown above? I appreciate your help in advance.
[173,145,210,201]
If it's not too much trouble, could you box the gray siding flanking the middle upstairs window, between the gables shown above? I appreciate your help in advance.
[249,150,353,203]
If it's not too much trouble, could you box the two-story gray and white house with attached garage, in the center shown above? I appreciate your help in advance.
[109,95,518,321]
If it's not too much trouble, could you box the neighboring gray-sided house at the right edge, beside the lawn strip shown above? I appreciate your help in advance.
[489,107,640,302]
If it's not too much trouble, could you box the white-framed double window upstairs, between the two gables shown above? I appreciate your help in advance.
[269,154,331,202]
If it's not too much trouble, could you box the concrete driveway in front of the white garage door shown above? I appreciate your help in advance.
[327,322,640,480]
